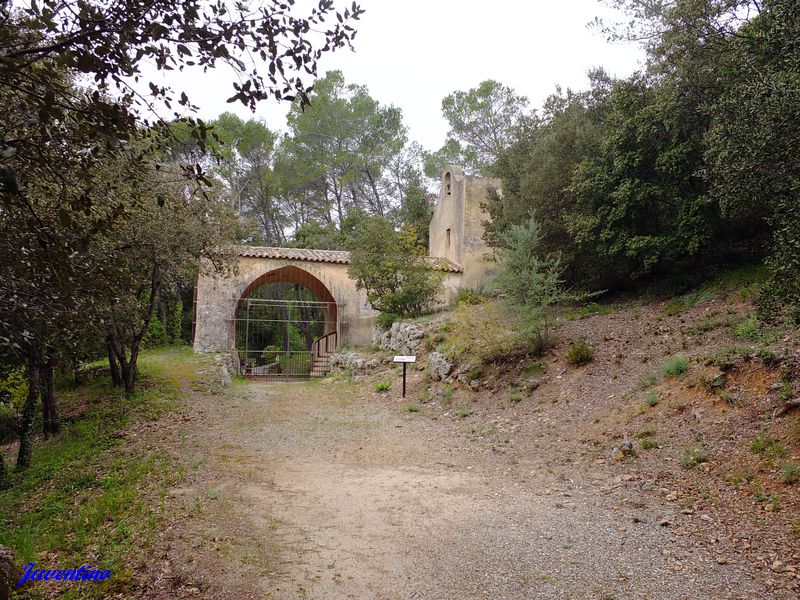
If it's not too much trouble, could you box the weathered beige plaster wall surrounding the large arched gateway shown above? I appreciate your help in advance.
[194,256,378,352]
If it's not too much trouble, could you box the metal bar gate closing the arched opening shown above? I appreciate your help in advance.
[234,298,340,379]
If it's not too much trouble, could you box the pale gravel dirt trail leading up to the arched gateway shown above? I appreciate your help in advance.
[145,380,790,599]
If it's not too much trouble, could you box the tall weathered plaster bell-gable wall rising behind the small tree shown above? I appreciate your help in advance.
[429,167,500,288]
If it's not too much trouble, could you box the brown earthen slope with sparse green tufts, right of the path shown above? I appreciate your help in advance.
[396,269,800,581]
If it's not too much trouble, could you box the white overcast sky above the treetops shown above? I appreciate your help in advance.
[153,0,643,150]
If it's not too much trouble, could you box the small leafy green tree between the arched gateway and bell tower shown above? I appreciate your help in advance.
[348,217,442,323]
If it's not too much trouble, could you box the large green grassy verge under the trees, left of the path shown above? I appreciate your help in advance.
[0,348,195,598]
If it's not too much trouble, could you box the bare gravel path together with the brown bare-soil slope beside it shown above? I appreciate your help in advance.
[140,296,800,599]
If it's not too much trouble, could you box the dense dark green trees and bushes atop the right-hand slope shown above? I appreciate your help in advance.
[486,0,800,304]
